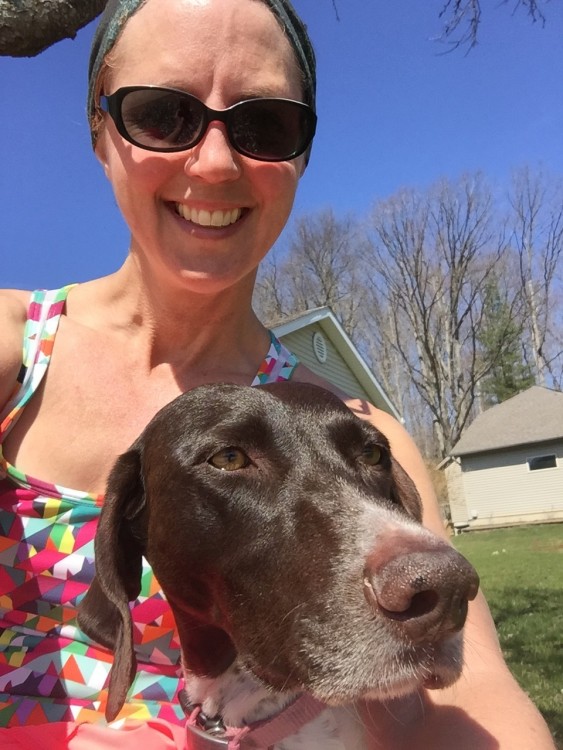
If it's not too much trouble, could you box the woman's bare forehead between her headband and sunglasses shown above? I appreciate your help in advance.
[110,0,302,98]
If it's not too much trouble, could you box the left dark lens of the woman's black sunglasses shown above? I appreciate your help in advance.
[121,89,203,150]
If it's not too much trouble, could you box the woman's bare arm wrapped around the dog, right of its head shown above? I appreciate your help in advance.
[348,401,555,750]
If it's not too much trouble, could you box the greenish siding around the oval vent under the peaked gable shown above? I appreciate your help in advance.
[281,323,370,401]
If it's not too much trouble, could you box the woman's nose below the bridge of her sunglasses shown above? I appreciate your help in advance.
[184,122,241,183]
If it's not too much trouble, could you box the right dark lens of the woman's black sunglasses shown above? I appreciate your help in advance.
[229,99,316,161]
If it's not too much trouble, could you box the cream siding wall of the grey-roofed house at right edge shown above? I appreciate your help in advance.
[460,440,563,528]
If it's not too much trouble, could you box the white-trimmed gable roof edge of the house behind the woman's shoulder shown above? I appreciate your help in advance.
[268,307,402,421]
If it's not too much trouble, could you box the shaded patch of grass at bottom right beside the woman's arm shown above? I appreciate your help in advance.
[489,587,563,750]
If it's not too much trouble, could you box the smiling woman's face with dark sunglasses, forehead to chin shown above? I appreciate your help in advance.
[87,3,314,296]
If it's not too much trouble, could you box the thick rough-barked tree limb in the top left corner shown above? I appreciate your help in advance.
[0,0,106,57]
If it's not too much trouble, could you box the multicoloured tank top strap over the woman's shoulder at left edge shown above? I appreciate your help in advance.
[0,284,74,443]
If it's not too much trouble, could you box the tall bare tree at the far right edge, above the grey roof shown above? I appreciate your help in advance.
[510,168,563,388]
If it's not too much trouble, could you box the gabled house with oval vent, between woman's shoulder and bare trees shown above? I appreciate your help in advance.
[270,307,401,420]
